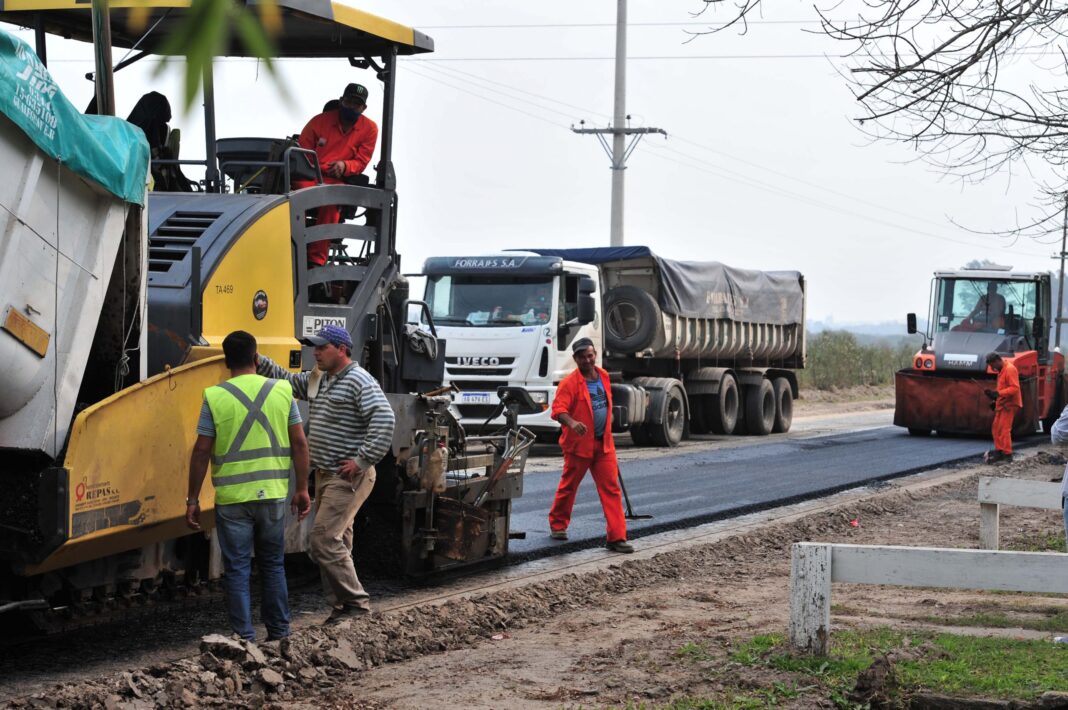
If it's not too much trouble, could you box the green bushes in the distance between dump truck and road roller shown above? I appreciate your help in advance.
[798,330,923,390]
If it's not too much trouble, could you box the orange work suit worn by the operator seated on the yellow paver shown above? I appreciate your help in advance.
[293,111,378,266]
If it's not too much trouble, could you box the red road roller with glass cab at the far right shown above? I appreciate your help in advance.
[894,267,1066,437]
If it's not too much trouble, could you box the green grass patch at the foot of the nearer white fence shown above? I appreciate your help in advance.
[731,629,1068,707]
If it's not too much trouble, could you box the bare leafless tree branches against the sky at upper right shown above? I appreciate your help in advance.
[697,0,1068,236]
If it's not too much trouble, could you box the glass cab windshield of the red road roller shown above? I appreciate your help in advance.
[935,279,1037,335]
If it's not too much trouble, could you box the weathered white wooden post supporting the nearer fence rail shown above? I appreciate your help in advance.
[790,542,831,656]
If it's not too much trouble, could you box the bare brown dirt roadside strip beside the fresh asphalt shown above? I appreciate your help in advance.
[13,452,1068,710]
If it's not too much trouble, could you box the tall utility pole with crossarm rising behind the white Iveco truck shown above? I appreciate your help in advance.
[571,0,668,247]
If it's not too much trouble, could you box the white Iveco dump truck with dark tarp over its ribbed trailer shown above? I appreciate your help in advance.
[424,247,805,446]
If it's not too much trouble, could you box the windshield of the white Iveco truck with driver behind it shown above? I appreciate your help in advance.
[426,274,552,328]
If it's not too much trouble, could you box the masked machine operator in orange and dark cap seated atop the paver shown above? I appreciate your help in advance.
[293,83,378,267]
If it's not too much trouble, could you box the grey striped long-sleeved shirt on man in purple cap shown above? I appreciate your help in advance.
[257,356,395,471]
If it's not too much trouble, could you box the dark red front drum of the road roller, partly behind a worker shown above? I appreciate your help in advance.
[894,369,1038,436]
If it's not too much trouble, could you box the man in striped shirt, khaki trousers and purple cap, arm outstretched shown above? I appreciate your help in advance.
[257,326,394,624]
